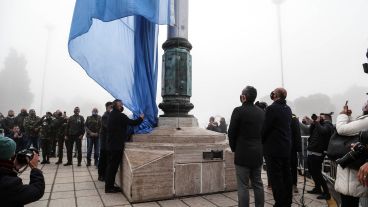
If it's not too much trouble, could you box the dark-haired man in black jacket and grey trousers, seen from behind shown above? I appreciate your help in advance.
[228,86,264,207]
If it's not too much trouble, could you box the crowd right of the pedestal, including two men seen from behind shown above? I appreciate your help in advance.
[224,86,368,207]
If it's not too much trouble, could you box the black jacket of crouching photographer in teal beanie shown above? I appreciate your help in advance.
[0,161,45,207]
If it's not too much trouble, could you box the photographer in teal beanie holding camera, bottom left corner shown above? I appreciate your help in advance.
[0,135,45,207]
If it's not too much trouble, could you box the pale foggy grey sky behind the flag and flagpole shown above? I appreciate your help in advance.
[0,0,368,126]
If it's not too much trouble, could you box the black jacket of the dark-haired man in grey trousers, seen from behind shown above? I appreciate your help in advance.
[228,103,264,168]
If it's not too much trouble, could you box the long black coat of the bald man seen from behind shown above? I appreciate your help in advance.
[262,99,292,157]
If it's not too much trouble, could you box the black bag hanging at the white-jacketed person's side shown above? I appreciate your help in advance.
[327,130,359,161]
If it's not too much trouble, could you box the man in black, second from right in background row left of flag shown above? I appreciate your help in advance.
[64,106,85,166]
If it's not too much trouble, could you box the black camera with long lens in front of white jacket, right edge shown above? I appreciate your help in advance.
[336,131,368,168]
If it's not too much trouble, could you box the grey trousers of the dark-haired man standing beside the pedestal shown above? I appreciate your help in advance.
[235,165,264,207]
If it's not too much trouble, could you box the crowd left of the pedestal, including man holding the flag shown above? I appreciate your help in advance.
[0,99,144,206]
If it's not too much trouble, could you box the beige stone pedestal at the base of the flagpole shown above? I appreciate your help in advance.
[120,117,236,202]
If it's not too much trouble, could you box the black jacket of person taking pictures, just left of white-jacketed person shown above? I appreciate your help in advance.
[307,121,334,153]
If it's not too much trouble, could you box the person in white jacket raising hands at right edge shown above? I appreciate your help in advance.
[335,102,368,207]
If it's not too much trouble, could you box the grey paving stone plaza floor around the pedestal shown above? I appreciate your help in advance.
[21,142,328,207]
